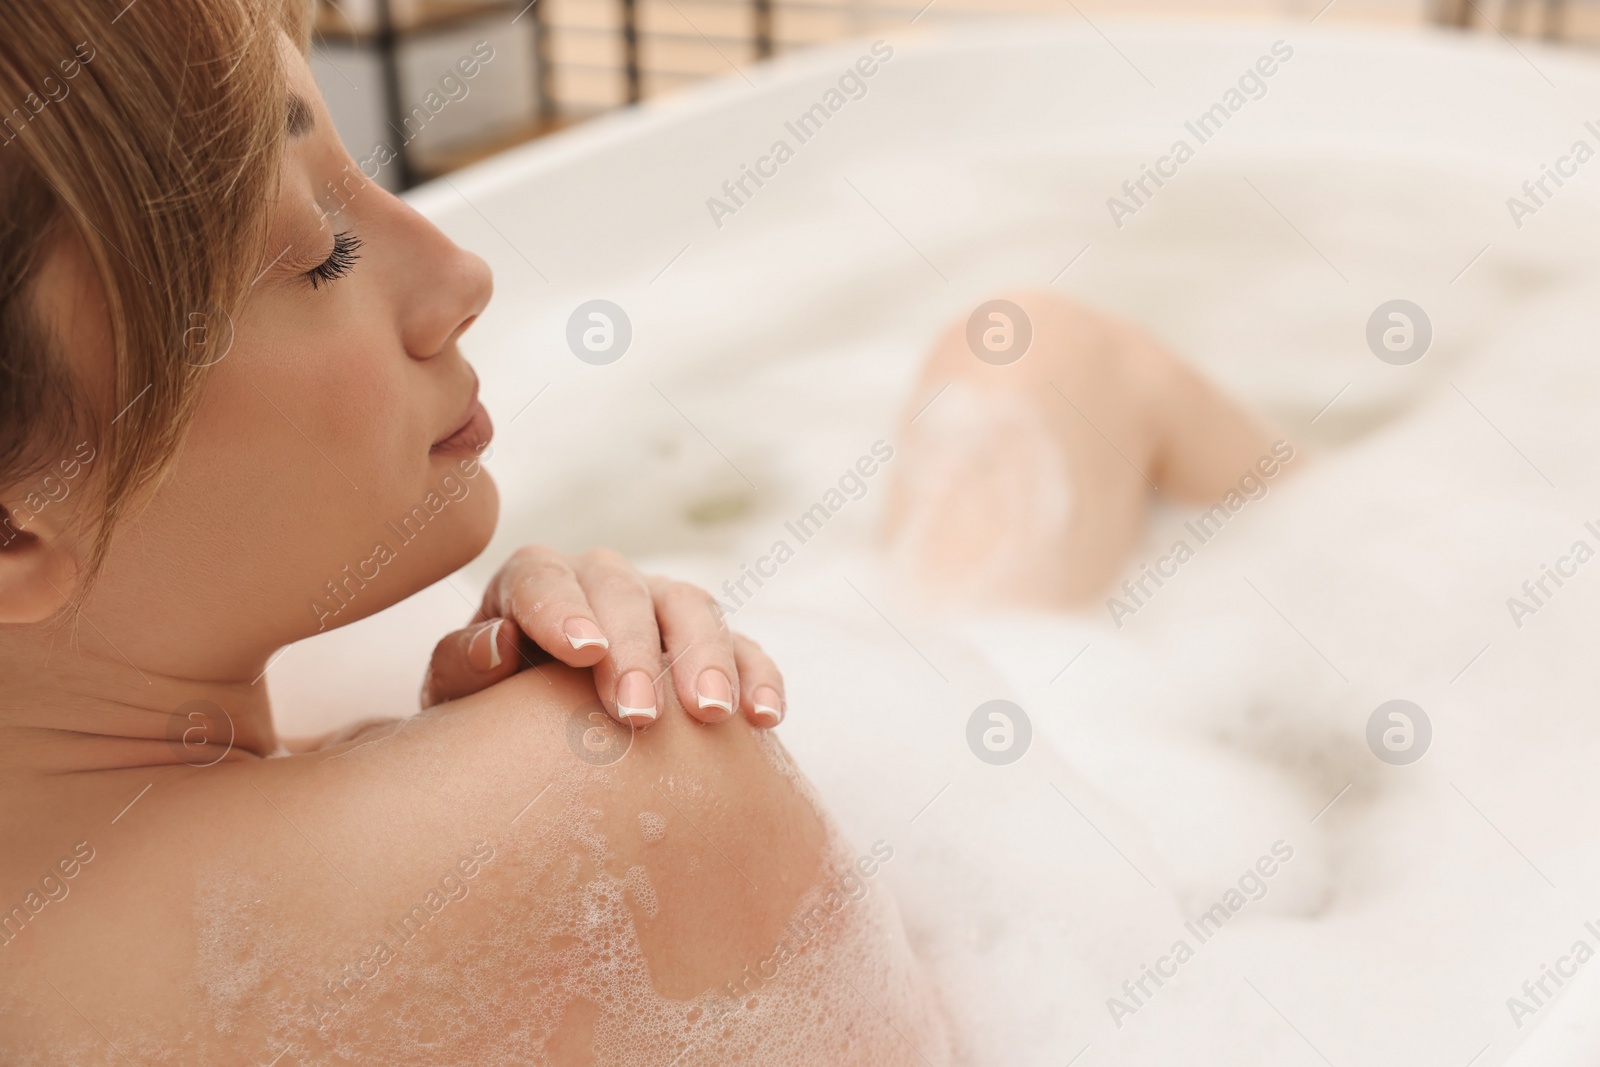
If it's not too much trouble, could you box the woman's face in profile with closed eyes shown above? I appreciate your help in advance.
[42,38,499,680]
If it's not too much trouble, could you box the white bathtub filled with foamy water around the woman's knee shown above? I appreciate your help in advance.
[270,19,1600,1067]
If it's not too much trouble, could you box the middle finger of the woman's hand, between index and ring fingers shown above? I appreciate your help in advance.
[578,549,666,726]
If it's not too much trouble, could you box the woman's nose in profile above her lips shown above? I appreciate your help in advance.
[400,202,494,360]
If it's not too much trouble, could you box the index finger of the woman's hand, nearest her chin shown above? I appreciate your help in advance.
[483,545,610,667]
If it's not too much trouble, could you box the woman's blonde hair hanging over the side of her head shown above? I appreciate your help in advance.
[0,0,310,576]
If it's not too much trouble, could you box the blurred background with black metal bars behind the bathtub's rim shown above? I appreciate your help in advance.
[314,0,1600,190]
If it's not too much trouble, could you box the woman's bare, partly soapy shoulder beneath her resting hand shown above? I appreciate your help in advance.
[0,667,920,1067]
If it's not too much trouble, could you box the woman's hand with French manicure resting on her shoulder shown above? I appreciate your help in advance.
[422,545,784,728]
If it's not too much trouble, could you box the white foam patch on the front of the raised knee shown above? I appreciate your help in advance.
[894,381,1075,600]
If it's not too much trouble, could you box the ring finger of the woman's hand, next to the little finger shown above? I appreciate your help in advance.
[645,574,739,723]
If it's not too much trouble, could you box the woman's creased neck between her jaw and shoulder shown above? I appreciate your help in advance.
[0,616,278,774]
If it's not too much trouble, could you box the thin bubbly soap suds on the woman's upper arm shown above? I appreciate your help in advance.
[193,751,950,1067]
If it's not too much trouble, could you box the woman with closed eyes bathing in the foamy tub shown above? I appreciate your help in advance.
[0,0,1258,1064]
